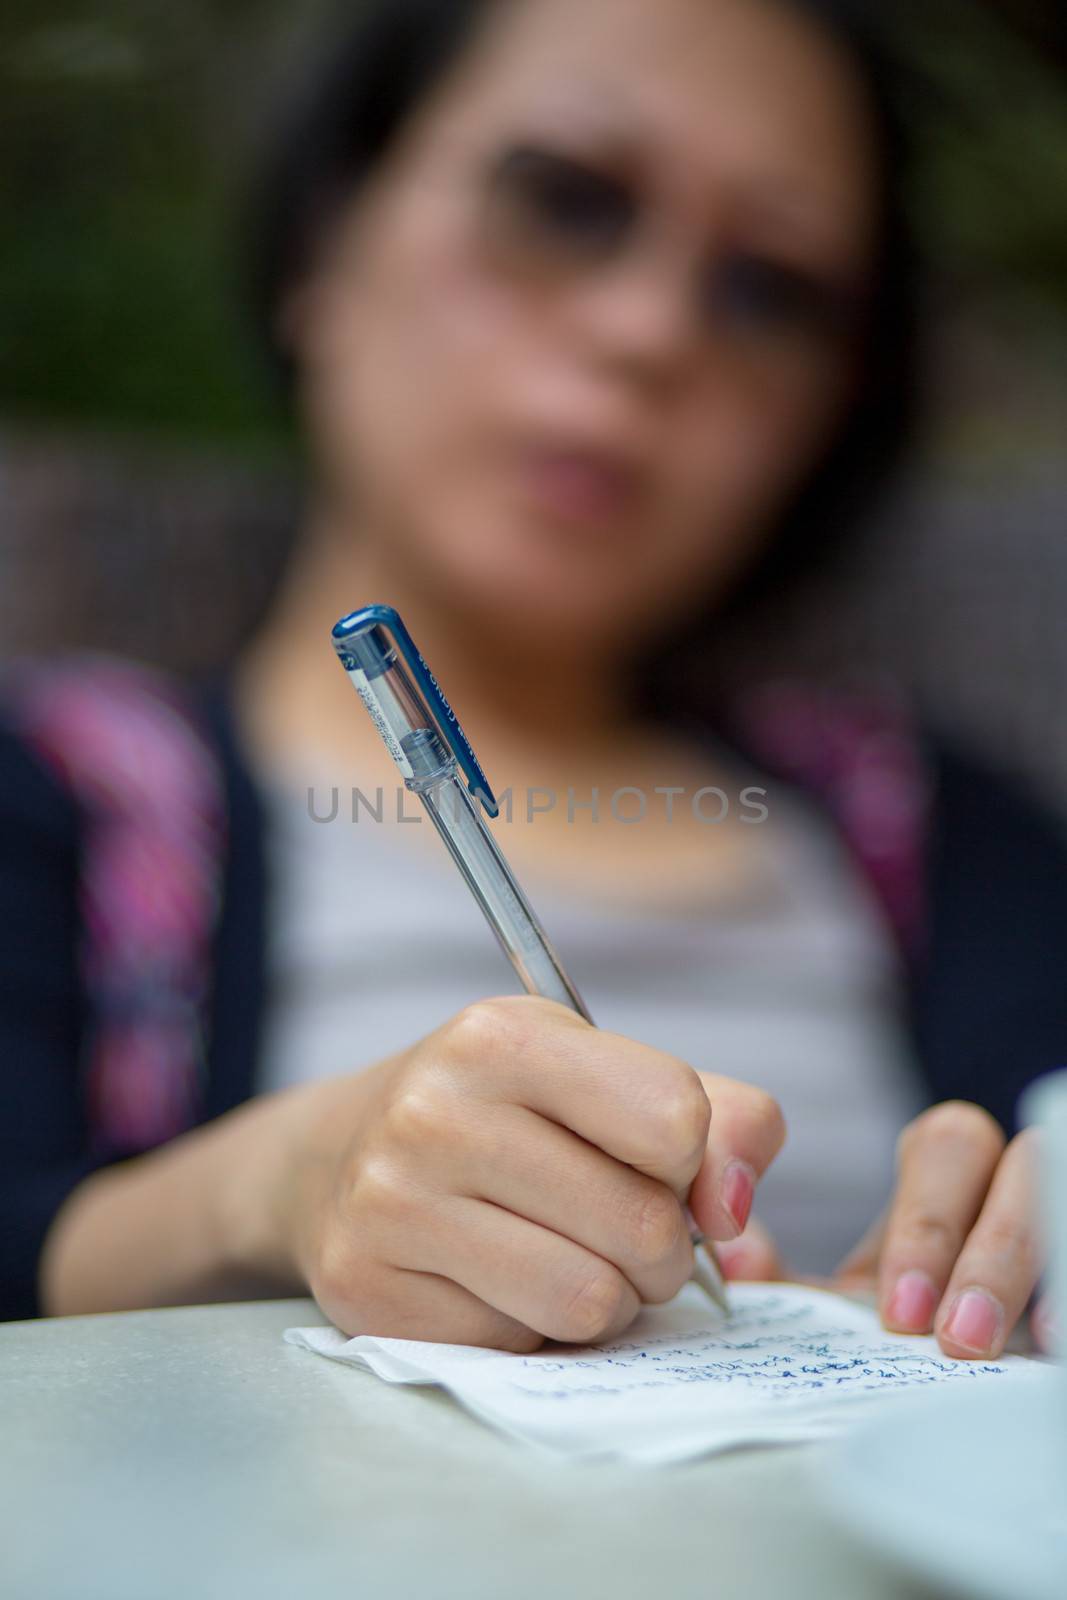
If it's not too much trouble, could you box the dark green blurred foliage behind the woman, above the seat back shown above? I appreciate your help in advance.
[0,0,1067,453]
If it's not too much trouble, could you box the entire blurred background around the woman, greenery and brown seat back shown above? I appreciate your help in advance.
[0,0,1067,800]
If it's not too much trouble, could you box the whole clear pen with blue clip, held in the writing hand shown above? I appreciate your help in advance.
[333,605,729,1314]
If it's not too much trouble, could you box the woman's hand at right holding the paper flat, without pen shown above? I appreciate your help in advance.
[718,1101,1048,1360]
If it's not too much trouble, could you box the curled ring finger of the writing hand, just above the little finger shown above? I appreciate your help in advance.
[388,1178,641,1344]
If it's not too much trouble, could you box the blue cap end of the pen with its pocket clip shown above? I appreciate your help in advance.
[331,605,499,816]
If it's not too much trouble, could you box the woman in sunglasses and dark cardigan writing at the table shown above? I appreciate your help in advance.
[0,0,1067,1358]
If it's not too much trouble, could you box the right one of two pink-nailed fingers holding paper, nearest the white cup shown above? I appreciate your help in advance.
[934,1130,1040,1358]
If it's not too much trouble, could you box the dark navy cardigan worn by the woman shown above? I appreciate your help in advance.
[0,668,1067,1320]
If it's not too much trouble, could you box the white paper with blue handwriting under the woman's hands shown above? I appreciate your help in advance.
[285,1283,1041,1462]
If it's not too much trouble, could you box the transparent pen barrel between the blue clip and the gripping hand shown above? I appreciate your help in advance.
[416,776,590,1021]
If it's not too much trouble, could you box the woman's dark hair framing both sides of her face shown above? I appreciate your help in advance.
[251,0,915,688]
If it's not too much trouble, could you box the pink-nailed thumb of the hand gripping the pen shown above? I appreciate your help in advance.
[689,1072,785,1242]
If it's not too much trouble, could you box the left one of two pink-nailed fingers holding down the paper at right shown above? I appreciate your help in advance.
[878,1101,1005,1333]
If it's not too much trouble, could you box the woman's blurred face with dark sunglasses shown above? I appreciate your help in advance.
[288,0,877,650]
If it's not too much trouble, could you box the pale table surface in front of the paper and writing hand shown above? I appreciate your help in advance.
[0,1301,931,1600]
